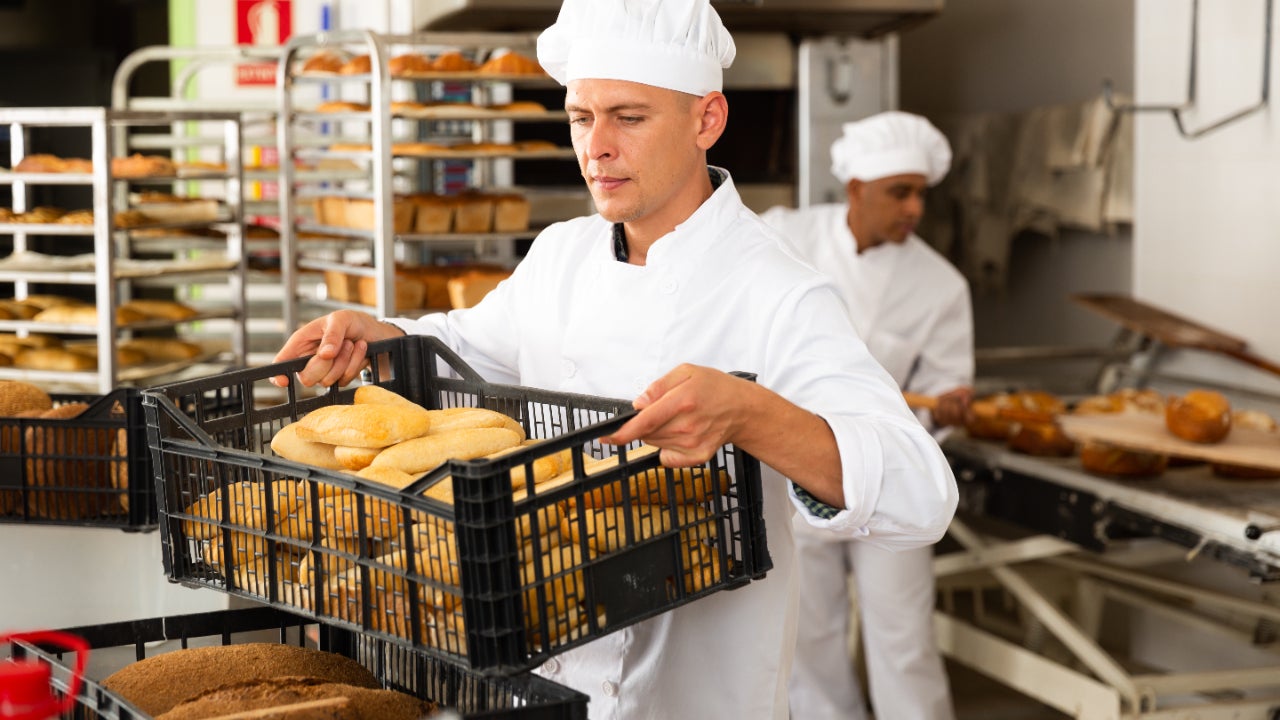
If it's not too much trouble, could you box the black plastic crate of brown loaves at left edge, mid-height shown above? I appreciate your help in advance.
[0,388,156,530]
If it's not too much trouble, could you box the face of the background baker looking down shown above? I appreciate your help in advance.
[846,174,928,250]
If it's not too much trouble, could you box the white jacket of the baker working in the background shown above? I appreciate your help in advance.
[760,204,974,415]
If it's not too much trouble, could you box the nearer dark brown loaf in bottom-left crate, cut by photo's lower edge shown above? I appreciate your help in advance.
[156,678,435,720]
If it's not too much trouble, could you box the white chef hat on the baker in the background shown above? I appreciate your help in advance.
[831,111,951,184]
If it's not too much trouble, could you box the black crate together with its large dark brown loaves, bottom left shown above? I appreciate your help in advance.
[0,607,588,720]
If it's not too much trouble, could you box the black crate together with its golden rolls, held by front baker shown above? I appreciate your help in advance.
[145,336,769,671]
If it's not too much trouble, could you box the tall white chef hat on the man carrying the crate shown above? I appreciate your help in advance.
[538,0,736,97]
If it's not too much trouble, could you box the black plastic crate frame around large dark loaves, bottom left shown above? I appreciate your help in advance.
[0,607,588,720]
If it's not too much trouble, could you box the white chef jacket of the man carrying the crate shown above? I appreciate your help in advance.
[393,169,956,720]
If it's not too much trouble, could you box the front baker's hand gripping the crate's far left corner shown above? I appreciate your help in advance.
[271,310,403,387]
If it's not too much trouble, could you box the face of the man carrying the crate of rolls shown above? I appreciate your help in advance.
[564,79,707,223]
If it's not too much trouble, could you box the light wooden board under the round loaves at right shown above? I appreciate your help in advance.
[1057,413,1280,470]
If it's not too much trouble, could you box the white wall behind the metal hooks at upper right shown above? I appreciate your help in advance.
[1134,0,1280,359]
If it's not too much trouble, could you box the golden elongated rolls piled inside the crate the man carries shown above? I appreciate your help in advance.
[168,376,733,659]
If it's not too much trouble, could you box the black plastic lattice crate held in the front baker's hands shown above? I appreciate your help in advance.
[143,337,772,674]
